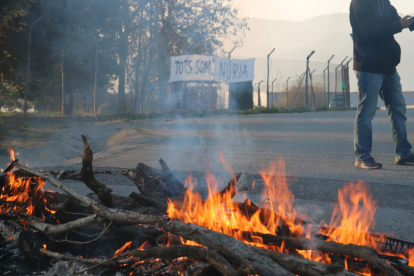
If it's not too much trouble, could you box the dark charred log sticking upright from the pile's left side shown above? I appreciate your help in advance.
[81,135,114,208]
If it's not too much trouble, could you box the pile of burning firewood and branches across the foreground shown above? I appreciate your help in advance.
[0,136,414,276]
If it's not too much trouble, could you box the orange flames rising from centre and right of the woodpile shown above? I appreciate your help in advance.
[167,153,414,275]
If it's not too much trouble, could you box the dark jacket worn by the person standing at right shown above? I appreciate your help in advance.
[350,0,402,74]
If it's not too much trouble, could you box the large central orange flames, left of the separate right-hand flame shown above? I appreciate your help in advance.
[167,154,303,250]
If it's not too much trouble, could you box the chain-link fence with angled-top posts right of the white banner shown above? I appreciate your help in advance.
[247,58,349,107]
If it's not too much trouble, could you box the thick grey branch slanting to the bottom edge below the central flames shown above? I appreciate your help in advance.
[163,221,294,276]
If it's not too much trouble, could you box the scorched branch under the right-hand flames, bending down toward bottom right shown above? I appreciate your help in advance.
[254,235,402,276]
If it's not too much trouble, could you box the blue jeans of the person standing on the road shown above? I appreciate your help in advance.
[354,71,412,161]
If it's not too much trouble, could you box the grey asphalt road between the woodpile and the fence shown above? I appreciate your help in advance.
[0,109,414,242]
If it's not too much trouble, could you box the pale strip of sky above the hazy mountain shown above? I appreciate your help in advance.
[233,0,414,21]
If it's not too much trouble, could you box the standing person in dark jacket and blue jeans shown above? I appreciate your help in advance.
[350,0,414,170]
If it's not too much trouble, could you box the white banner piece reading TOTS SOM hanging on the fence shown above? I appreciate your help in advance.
[170,55,215,82]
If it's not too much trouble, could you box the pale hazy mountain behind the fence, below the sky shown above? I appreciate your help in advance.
[225,13,414,91]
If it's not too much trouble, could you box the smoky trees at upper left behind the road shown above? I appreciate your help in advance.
[0,0,247,115]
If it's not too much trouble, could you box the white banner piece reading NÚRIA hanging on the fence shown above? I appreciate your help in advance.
[214,57,255,83]
